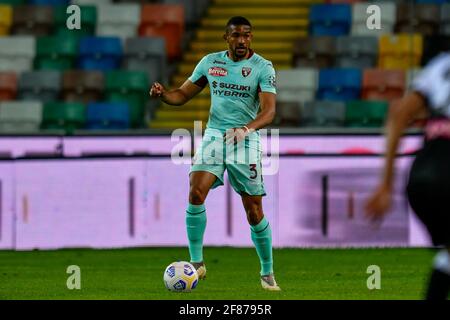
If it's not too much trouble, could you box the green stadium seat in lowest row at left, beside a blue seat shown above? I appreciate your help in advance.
[41,102,86,134]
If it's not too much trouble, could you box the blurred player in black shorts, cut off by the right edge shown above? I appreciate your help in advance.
[366,53,450,300]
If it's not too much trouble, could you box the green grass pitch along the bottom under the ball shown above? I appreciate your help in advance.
[0,247,434,300]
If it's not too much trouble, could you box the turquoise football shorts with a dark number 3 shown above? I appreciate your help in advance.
[190,129,266,196]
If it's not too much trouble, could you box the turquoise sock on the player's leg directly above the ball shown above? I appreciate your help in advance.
[186,203,206,262]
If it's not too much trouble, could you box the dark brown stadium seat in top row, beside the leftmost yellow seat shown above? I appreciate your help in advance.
[11,5,54,36]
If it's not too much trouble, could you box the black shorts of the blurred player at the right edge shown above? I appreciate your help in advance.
[407,138,450,246]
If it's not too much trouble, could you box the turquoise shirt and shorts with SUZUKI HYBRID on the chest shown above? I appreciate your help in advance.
[189,51,276,195]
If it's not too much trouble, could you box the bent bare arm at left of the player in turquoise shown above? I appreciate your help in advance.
[150,80,203,106]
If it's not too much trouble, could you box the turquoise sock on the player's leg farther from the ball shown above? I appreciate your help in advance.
[250,217,273,275]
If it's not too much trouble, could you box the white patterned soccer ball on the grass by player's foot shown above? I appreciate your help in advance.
[164,261,198,292]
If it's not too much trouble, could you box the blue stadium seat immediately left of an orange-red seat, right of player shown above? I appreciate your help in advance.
[317,68,362,102]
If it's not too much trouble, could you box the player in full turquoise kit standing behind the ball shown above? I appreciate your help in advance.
[150,16,280,291]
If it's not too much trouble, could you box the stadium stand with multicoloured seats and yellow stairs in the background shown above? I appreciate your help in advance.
[0,0,450,131]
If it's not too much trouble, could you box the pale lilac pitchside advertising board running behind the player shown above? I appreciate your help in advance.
[0,135,430,250]
